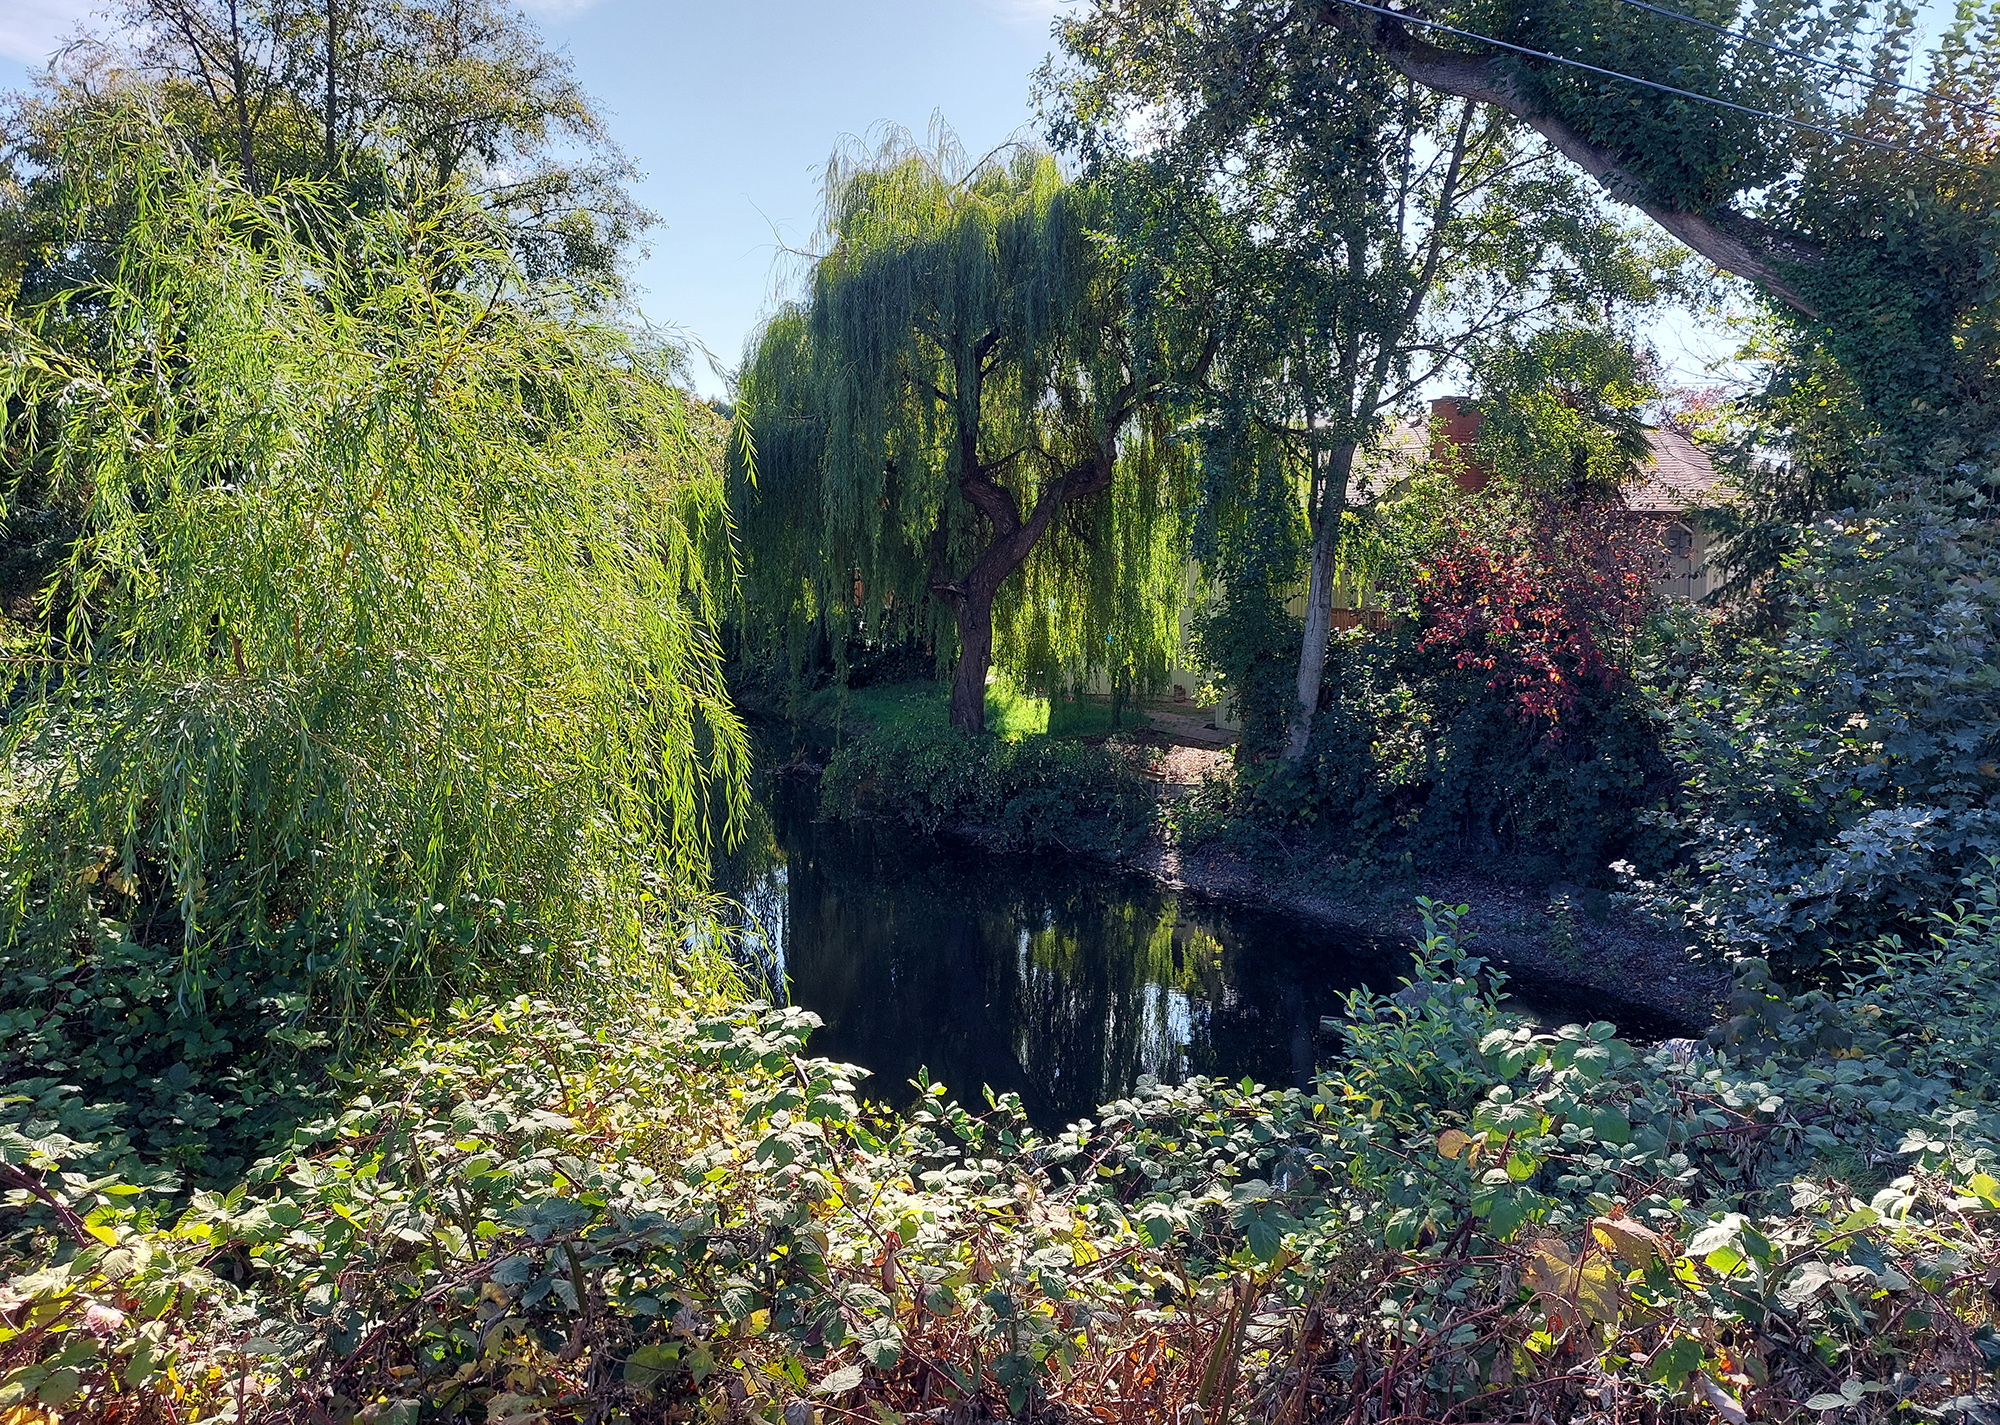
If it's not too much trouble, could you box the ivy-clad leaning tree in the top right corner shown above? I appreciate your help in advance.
[1066,0,2000,450]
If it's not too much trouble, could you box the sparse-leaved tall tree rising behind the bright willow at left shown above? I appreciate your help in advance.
[0,0,652,306]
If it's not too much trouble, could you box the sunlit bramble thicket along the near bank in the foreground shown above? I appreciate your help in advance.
[11,881,2000,1423]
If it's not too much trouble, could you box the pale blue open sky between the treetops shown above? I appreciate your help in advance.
[0,0,1060,394]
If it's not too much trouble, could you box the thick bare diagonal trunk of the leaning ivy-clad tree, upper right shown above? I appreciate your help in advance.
[1320,0,1824,318]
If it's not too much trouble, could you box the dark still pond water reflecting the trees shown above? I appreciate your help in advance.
[718,777,1672,1129]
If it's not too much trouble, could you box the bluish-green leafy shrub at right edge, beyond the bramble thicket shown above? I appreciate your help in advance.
[1640,468,2000,975]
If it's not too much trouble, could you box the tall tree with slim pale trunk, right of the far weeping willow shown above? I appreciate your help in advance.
[1044,16,1662,763]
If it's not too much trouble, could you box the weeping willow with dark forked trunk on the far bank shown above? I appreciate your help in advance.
[736,138,1206,733]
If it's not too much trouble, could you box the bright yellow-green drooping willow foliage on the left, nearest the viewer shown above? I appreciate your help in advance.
[0,136,744,1017]
